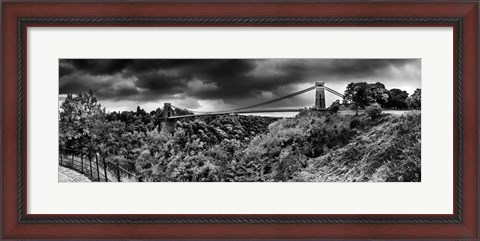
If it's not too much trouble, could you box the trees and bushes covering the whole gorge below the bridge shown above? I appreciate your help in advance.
[59,83,421,182]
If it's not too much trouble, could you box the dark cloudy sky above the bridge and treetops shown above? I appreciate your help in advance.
[59,59,421,111]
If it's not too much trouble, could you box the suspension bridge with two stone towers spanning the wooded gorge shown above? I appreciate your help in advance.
[155,82,343,132]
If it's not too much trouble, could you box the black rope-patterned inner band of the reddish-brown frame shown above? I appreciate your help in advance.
[16,17,463,224]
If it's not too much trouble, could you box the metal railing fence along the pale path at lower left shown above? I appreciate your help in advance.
[59,148,139,182]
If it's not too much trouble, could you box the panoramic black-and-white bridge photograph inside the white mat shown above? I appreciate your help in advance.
[58,58,422,182]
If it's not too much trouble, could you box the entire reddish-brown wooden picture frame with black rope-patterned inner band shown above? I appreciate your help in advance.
[0,1,479,239]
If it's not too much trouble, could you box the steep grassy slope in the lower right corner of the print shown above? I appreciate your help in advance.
[293,114,421,182]
